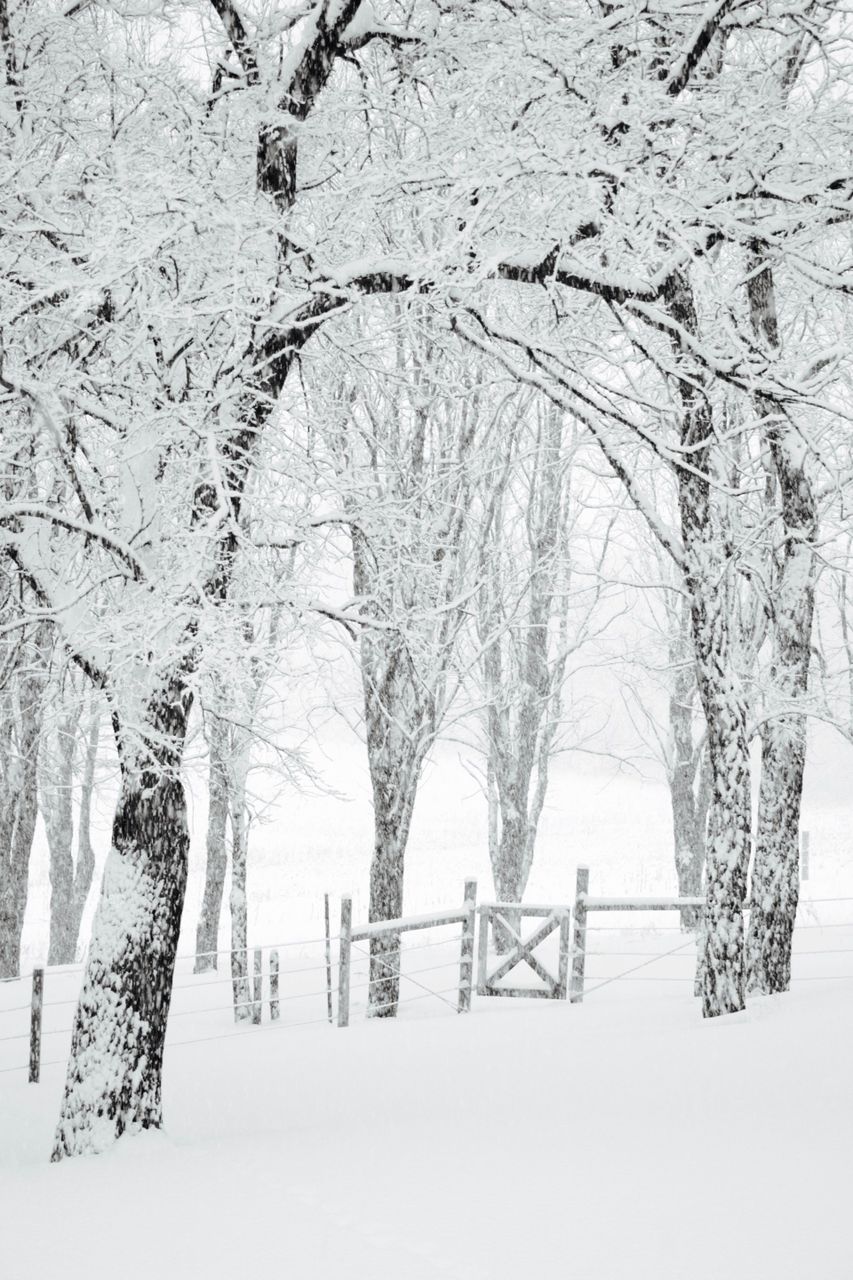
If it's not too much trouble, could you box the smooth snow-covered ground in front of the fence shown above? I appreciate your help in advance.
[0,967,853,1280]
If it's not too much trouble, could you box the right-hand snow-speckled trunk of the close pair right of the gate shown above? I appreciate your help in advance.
[747,246,817,992]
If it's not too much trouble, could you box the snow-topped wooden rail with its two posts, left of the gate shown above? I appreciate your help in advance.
[338,879,476,1027]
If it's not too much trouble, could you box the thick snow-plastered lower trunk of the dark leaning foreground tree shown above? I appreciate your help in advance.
[51,680,190,1161]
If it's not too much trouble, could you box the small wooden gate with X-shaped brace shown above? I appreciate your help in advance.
[476,902,571,1000]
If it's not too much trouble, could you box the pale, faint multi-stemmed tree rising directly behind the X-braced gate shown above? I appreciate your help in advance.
[473,396,612,951]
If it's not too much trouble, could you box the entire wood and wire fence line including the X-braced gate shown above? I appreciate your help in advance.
[0,868,853,1083]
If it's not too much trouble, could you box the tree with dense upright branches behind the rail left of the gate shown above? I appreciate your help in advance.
[312,327,506,1018]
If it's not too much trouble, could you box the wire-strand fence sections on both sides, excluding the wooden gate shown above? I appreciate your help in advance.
[0,896,853,1075]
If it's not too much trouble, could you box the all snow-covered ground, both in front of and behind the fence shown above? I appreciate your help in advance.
[0,742,853,1280]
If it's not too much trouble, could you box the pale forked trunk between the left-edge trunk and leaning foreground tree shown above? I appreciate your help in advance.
[41,699,100,965]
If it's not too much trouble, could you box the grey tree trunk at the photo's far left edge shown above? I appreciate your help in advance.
[0,627,47,978]
